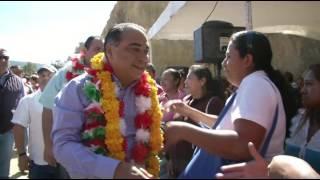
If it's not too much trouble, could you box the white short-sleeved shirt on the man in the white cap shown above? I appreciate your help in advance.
[12,90,48,165]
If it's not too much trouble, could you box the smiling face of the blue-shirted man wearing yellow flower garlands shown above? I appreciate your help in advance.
[106,30,150,85]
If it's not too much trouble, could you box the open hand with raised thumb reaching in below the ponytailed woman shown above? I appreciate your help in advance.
[216,142,268,179]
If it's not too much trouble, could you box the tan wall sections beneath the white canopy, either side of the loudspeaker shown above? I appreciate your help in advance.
[152,34,320,78]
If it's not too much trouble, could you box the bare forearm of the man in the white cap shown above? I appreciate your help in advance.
[13,124,26,154]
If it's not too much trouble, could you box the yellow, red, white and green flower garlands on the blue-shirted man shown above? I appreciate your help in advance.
[82,53,163,177]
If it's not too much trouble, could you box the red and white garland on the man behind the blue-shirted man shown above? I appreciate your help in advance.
[66,53,85,81]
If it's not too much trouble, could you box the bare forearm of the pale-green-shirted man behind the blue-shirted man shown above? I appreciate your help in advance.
[42,107,53,147]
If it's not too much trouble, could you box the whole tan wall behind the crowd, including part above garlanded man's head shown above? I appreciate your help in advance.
[102,1,320,78]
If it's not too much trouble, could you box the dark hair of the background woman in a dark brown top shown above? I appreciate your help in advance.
[189,65,225,100]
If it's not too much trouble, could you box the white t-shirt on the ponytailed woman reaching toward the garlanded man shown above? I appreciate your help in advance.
[217,71,286,159]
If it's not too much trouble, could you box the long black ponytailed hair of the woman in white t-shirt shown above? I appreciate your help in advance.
[231,31,297,138]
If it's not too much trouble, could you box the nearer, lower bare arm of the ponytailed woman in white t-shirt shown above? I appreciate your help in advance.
[165,119,266,160]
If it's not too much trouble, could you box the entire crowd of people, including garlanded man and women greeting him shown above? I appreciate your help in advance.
[0,23,320,179]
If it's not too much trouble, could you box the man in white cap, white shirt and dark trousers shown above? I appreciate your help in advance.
[12,65,60,179]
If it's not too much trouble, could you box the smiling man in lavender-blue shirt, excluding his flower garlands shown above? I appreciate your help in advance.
[52,23,160,179]
